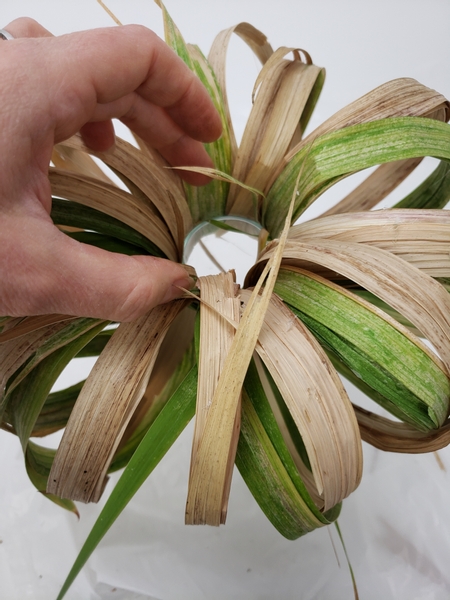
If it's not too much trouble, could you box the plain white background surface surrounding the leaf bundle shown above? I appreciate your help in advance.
[0,0,450,600]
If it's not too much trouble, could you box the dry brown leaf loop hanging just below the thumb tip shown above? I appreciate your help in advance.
[47,300,186,502]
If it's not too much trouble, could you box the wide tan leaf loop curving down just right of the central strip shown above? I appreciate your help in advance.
[241,290,362,510]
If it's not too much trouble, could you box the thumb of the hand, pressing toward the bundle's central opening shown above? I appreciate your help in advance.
[0,213,192,321]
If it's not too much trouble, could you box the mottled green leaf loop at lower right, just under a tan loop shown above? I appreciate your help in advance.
[275,270,450,430]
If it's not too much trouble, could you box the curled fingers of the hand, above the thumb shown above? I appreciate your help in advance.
[2,19,222,183]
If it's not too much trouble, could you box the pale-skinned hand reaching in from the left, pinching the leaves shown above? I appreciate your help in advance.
[0,19,221,321]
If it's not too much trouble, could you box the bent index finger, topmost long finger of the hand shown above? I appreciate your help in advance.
[46,25,222,142]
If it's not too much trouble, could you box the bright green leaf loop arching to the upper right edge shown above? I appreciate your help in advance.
[263,117,450,237]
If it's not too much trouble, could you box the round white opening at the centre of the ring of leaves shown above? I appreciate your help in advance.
[183,216,262,286]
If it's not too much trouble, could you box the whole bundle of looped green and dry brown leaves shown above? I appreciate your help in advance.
[0,3,450,597]
